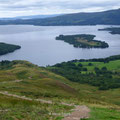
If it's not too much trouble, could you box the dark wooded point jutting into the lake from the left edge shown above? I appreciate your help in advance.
[0,43,21,55]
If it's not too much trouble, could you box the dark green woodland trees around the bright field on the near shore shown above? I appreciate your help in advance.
[49,56,120,90]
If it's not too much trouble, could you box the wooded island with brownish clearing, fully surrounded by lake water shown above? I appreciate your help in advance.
[56,34,109,48]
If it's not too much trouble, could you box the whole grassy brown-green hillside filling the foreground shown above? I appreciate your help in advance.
[0,61,120,120]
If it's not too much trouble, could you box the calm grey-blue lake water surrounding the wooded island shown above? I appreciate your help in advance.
[0,25,120,66]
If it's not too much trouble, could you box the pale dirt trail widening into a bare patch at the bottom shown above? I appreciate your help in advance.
[0,91,90,120]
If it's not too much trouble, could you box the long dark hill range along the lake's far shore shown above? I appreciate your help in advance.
[0,9,120,26]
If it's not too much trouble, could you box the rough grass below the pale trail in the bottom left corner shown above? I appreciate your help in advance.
[0,95,72,120]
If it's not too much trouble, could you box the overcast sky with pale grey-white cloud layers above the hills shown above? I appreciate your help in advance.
[0,0,120,17]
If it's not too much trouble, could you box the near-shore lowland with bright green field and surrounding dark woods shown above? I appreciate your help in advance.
[48,56,120,90]
